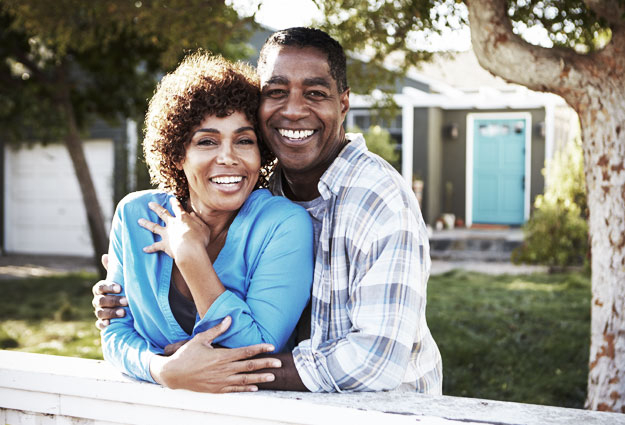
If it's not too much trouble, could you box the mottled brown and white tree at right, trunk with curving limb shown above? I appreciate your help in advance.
[467,0,625,412]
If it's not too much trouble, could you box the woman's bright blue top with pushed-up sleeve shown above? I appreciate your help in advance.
[102,189,314,382]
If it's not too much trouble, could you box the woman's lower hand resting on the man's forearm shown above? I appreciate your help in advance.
[150,317,281,393]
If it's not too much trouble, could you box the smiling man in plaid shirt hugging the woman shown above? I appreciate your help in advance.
[94,28,442,394]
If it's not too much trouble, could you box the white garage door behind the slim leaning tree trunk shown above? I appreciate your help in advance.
[4,140,113,256]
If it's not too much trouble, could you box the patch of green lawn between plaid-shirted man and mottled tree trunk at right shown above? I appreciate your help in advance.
[427,270,591,408]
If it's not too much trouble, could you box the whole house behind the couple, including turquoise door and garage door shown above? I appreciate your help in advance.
[0,41,574,256]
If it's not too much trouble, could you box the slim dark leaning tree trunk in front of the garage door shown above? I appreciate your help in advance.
[58,85,108,277]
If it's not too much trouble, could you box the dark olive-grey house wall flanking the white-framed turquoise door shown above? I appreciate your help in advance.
[441,109,545,224]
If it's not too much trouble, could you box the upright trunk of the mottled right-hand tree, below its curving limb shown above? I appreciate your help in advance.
[578,83,625,413]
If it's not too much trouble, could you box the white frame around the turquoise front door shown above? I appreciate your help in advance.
[465,112,532,227]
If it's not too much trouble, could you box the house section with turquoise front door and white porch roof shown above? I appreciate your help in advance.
[347,51,575,226]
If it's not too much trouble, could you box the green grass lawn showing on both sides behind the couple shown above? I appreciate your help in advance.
[0,271,590,407]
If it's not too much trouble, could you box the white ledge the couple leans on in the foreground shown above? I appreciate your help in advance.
[0,350,625,425]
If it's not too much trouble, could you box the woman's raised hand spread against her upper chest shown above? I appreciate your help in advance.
[139,198,210,260]
